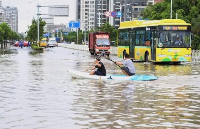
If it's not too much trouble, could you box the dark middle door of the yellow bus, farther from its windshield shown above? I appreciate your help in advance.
[129,31,135,58]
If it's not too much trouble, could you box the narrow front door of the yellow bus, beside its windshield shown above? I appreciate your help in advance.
[151,30,157,60]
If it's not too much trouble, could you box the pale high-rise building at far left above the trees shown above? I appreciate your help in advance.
[3,6,18,32]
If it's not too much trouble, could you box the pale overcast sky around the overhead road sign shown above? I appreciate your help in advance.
[1,0,76,32]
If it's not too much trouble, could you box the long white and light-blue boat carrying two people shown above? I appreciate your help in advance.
[68,70,158,81]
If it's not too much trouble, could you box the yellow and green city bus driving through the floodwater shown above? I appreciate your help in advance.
[117,19,192,62]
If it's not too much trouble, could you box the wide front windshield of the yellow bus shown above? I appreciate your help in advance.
[157,31,191,48]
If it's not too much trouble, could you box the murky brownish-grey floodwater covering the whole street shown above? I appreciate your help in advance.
[0,47,200,129]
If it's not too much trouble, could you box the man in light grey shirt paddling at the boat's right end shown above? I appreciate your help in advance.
[114,53,135,76]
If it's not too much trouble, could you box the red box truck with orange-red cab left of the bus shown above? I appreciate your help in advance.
[88,32,110,56]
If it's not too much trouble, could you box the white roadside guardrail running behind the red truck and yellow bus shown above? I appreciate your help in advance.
[59,43,200,63]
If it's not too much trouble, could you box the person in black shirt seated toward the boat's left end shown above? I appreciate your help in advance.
[86,58,106,76]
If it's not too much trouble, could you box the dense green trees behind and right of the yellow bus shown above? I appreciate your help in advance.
[141,0,200,49]
